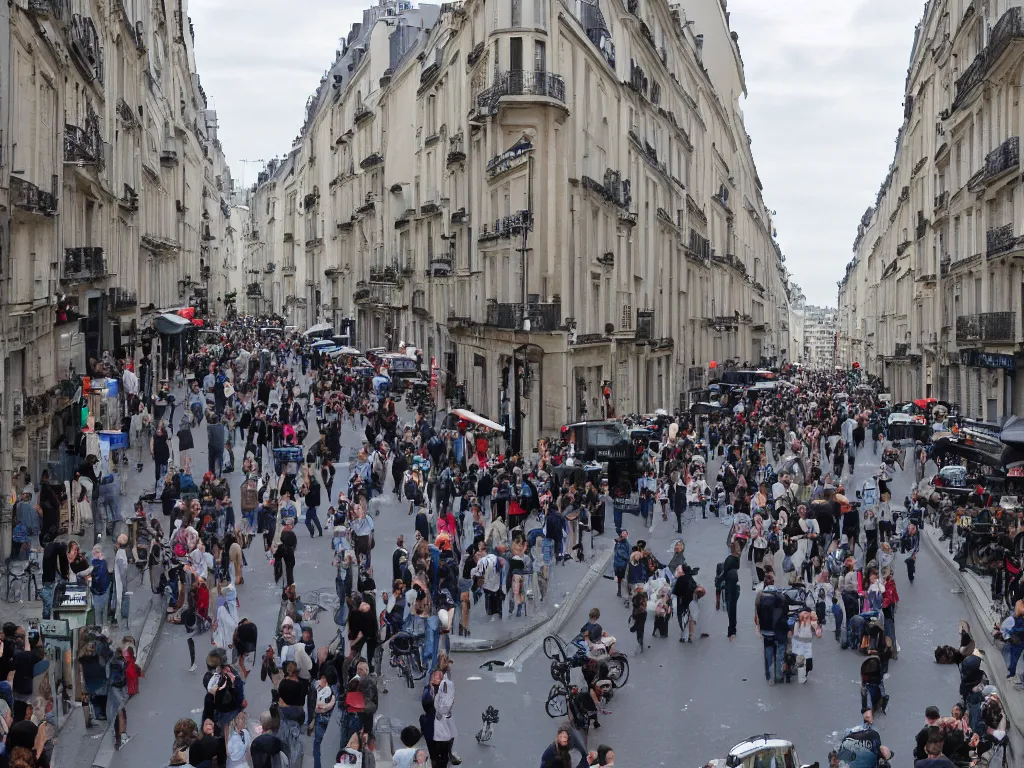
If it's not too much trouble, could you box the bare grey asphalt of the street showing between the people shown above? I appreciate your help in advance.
[99,427,1011,766]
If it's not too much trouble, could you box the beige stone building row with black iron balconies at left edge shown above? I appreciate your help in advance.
[0,0,231,505]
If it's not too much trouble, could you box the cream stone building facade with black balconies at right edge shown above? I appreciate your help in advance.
[838,0,1024,421]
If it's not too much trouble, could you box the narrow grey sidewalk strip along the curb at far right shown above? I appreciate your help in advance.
[922,525,1024,731]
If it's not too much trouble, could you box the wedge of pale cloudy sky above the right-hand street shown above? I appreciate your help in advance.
[729,0,924,306]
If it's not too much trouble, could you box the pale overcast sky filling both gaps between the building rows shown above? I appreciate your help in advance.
[188,0,924,306]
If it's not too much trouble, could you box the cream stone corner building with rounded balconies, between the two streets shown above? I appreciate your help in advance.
[246,0,791,444]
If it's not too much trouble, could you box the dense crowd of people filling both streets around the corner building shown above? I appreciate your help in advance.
[0,318,1024,768]
